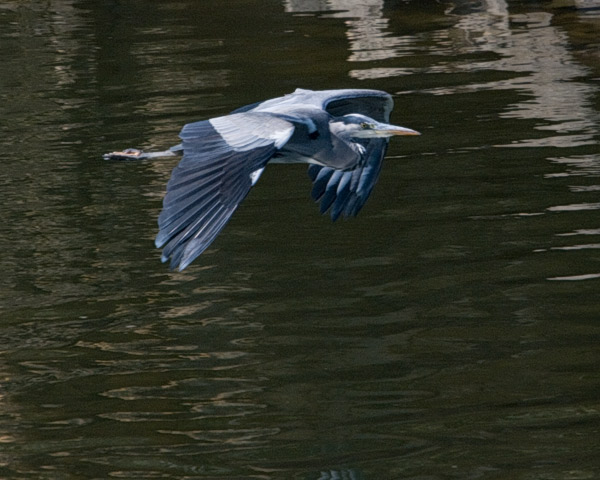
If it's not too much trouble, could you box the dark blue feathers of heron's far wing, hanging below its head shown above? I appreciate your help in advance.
[308,139,388,221]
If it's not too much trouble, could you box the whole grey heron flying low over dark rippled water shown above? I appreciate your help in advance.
[104,89,419,270]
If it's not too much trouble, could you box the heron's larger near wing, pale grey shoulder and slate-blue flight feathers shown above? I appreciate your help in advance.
[156,112,294,270]
